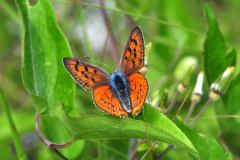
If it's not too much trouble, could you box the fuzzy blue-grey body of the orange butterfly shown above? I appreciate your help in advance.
[110,71,132,113]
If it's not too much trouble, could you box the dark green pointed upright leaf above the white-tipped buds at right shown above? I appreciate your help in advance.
[203,5,236,85]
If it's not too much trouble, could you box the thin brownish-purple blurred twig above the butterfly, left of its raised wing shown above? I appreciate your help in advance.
[99,0,119,64]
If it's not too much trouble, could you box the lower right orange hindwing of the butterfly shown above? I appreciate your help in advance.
[128,72,148,116]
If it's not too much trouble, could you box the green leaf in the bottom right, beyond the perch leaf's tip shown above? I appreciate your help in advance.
[176,121,231,160]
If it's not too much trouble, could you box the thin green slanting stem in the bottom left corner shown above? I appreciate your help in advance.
[0,88,27,159]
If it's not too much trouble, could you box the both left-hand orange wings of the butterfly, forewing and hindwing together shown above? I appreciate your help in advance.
[63,58,128,117]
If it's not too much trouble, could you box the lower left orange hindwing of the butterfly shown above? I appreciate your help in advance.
[93,85,128,117]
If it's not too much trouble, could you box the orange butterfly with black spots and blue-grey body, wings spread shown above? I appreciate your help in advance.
[63,27,149,117]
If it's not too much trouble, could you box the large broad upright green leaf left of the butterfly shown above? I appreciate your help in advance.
[16,0,75,114]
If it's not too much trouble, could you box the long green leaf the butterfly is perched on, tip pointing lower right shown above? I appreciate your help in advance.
[64,105,197,155]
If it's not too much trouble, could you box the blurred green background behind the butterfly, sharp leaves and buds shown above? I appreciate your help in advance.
[0,0,240,160]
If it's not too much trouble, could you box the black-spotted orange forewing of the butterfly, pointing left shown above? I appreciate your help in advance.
[63,58,109,90]
